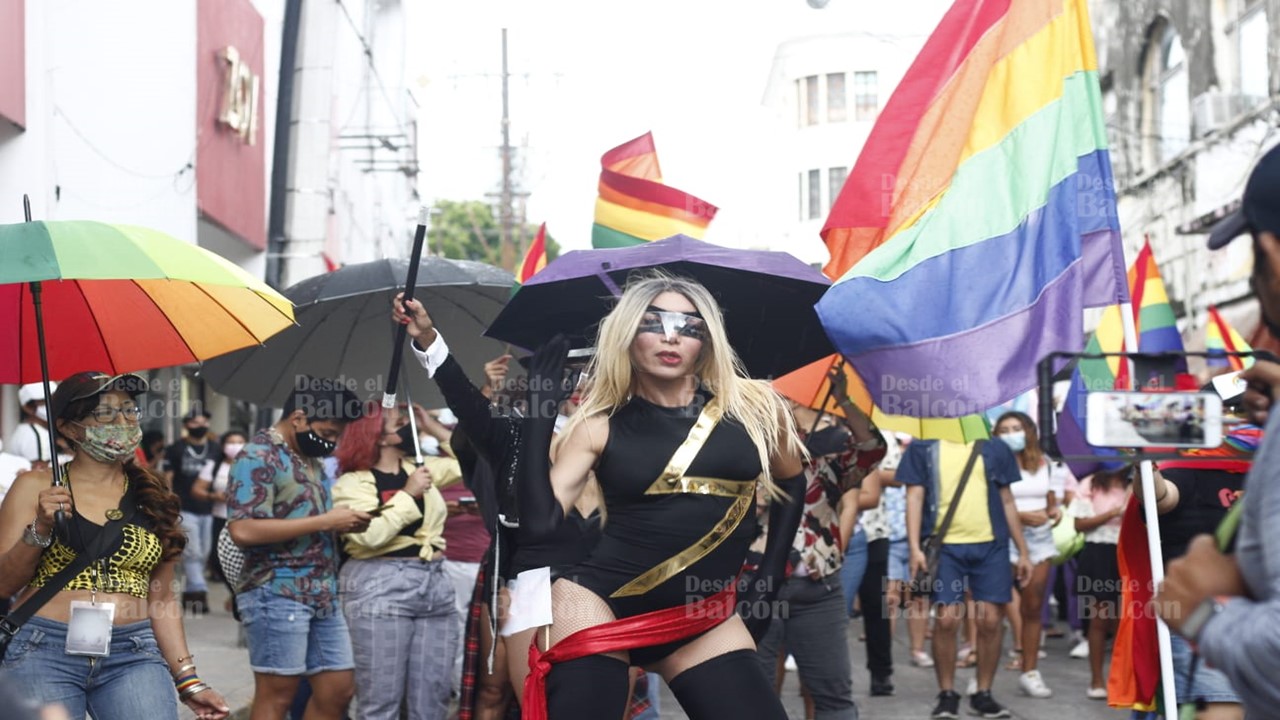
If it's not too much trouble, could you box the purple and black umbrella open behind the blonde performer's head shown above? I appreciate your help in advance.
[485,234,835,378]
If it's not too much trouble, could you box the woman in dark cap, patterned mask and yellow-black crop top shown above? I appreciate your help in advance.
[0,373,230,720]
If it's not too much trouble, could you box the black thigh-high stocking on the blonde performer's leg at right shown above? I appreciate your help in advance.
[668,650,787,720]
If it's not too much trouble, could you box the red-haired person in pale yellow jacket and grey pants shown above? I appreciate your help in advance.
[333,407,462,720]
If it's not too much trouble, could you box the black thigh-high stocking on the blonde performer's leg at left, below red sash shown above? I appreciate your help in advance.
[547,655,631,720]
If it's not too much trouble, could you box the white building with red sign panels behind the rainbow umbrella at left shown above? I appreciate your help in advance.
[0,0,416,436]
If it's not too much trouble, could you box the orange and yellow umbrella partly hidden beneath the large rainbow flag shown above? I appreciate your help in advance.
[773,355,991,442]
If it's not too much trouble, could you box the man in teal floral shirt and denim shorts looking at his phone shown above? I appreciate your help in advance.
[227,375,372,720]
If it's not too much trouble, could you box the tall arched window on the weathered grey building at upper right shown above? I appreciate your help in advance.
[1142,20,1192,167]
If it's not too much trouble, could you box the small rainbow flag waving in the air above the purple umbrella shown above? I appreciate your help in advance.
[591,132,717,247]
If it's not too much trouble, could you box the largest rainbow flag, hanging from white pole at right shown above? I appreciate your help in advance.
[817,0,1126,416]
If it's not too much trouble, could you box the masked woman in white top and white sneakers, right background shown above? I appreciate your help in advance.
[996,411,1062,698]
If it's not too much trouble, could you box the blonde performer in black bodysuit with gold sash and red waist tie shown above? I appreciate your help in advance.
[399,274,804,720]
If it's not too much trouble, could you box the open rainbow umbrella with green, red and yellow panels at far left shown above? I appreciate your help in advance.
[0,220,293,383]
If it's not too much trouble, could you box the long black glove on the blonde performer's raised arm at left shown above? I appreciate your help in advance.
[516,334,568,538]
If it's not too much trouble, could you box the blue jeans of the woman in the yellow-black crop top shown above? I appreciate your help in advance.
[0,616,178,720]
